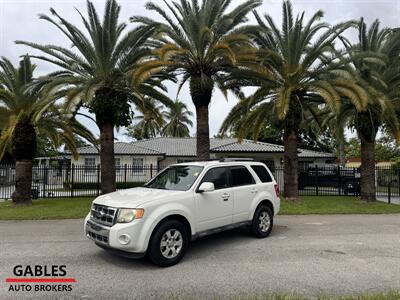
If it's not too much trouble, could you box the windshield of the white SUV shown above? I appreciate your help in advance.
[145,166,203,191]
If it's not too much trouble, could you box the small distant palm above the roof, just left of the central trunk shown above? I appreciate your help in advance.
[162,100,193,137]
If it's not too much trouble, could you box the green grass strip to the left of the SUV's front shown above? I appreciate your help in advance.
[0,197,93,220]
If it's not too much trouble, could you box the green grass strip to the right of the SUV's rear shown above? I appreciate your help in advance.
[280,196,400,215]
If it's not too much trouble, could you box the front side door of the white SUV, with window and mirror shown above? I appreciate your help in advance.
[194,167,233,232]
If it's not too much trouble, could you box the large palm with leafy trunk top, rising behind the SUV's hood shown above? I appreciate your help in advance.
[16,0,171,193]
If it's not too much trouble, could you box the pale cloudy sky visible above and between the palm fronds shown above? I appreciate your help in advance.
[0,0,400,141]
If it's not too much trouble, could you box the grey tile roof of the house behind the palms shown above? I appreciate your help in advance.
[72,137,335,158]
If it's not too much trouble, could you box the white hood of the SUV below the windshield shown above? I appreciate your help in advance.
[93,187,182,208]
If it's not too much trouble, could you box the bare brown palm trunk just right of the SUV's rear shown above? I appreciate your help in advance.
[283,130,299,201]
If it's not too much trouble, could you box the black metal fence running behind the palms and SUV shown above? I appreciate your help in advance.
[0,165,400,202]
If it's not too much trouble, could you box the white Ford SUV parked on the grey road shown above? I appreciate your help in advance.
[85,159,280,267]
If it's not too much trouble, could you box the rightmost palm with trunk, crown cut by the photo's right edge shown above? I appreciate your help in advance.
[336,19,400,201]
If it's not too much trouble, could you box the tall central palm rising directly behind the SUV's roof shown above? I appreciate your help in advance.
[131,0,262,160]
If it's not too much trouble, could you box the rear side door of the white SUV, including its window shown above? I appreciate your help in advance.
[229,165,258,223]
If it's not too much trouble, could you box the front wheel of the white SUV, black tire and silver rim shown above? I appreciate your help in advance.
[148,220,189,267]
